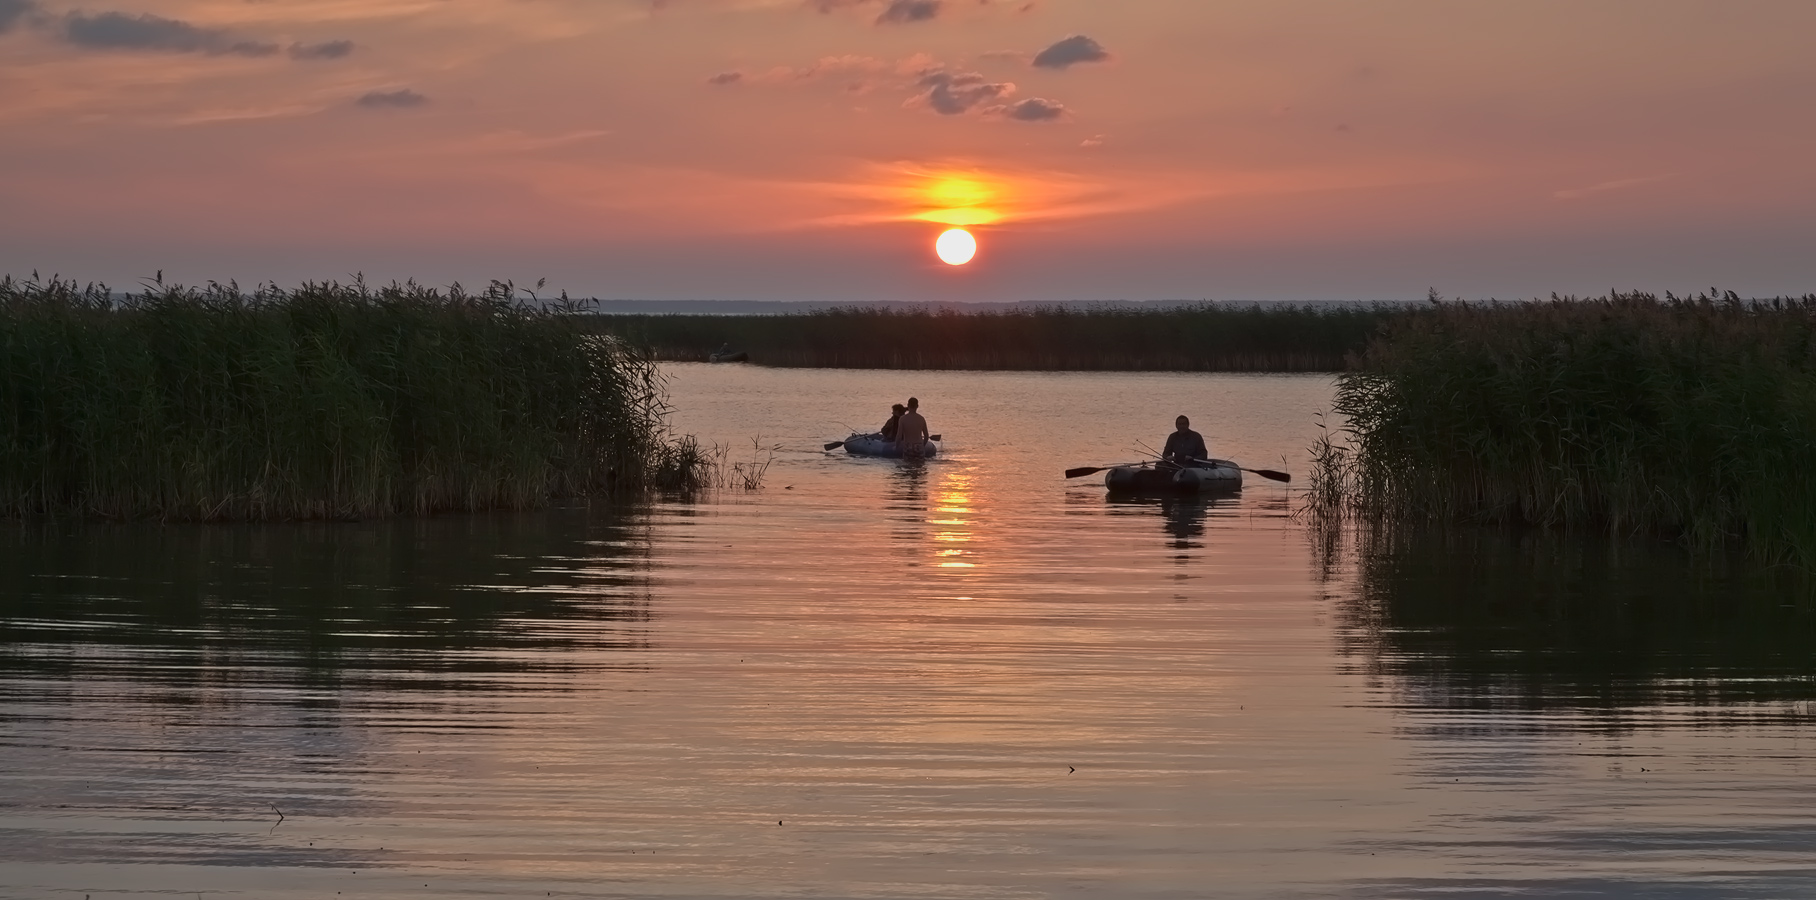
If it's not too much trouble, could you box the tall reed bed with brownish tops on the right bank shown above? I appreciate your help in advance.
[1308,292,1816,568]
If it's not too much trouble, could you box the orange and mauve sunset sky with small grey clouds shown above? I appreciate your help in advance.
[0,0,1816,301]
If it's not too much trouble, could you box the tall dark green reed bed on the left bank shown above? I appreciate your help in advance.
[0,276,712,521]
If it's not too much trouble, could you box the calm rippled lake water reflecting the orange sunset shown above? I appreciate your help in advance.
[0,365,1816,898]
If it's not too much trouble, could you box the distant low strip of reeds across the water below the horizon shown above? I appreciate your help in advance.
[587,303,1391,372]
